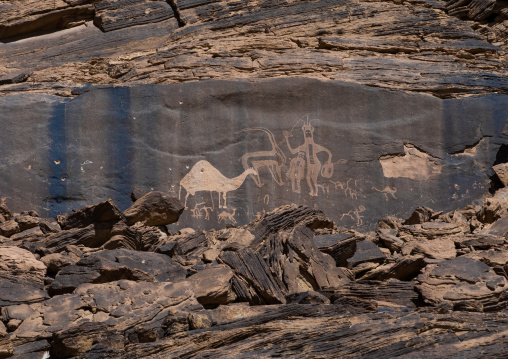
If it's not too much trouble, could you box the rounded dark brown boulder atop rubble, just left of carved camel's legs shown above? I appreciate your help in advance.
[124,191,184,226]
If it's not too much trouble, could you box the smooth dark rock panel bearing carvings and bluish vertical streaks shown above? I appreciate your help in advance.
[0,78,508,229]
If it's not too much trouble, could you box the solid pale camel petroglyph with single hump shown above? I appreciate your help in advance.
[178,160,257,208]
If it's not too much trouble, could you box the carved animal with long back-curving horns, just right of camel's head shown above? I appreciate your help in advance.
[240,127,286,187]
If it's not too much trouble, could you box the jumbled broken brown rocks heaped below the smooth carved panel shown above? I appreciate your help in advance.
[0,181,508,358]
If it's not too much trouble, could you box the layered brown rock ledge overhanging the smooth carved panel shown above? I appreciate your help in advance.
[0,0,508,97]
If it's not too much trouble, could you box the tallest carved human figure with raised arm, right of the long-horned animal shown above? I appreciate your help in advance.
[283,120,333,196]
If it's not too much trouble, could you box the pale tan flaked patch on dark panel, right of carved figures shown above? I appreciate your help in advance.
[379,143,443,181]
